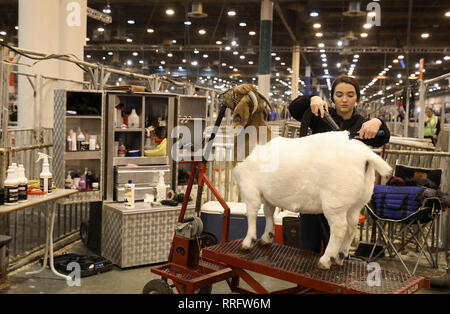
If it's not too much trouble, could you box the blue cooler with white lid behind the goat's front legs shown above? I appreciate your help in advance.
[201,201,266,242]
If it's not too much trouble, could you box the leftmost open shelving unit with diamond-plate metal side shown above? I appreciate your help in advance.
[50,90,105,204]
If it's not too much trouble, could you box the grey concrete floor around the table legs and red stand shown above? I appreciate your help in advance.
[0,241,450,294]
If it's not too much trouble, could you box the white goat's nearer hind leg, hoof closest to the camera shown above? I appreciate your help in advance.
[318,209,347,269]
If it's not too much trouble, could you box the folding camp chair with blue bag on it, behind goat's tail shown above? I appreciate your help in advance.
[366,165,442,274]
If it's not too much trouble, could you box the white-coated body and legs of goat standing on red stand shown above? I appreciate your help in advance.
[233,131,392,269]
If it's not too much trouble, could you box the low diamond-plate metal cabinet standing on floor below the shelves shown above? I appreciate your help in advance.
[101,202,195,268]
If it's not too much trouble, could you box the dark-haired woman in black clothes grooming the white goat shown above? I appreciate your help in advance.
[288,75,390,254]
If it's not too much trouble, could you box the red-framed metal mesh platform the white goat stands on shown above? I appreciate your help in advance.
[202,239,430,294]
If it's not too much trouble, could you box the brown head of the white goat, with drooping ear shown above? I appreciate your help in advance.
[222,84,273,127]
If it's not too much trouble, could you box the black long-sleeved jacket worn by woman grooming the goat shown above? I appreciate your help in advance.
[289,96,391,147]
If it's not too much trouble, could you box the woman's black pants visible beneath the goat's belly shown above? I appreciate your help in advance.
[300,214,330,254]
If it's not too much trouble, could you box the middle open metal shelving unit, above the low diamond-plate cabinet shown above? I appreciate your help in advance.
[105,92,176,201]
